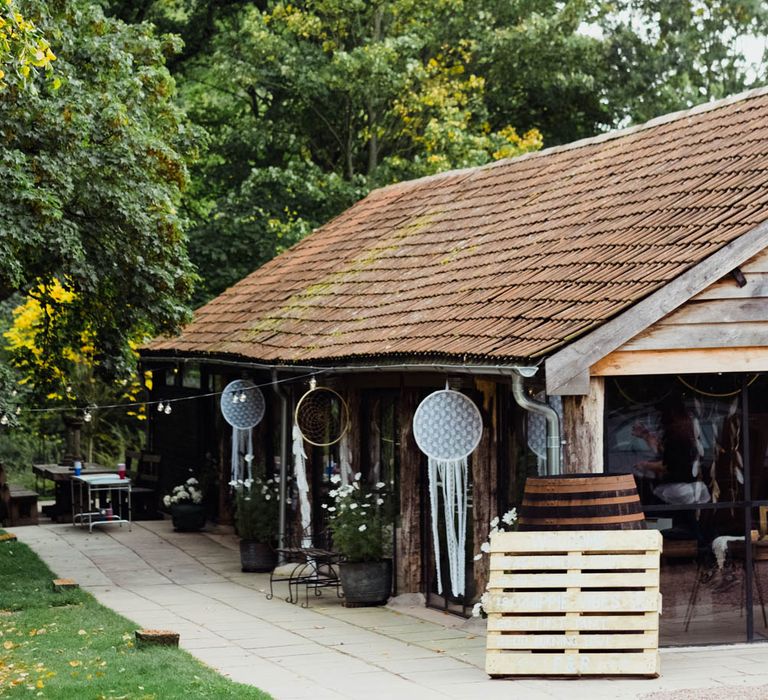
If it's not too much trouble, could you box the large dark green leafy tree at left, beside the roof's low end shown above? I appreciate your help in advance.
[0,0,194,382]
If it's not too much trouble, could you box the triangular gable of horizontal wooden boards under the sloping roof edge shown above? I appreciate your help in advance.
[590,249,768,376]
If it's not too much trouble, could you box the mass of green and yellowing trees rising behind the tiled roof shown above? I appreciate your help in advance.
[96,0,768,303]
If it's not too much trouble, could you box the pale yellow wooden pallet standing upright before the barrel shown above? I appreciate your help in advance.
[484,530,662,676]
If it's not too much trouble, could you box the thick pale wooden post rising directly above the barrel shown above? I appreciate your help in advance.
[563,377,605,474]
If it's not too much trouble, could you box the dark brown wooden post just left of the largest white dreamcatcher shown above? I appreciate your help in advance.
[398,386,422,593]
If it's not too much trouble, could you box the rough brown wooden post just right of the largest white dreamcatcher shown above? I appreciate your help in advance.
[470,379,498,596]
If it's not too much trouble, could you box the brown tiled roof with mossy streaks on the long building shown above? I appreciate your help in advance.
[146,90,768,363]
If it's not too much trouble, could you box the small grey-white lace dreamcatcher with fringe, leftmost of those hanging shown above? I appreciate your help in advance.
[220,379,266,481]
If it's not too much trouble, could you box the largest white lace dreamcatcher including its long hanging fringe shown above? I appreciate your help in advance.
[413,388,483,597]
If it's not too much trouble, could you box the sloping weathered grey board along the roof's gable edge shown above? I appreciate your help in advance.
[545,222,768,394]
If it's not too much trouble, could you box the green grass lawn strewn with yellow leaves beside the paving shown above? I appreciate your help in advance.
[0,530,270,700]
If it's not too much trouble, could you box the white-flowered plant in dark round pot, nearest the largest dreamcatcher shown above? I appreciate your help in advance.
[324,472,392,605]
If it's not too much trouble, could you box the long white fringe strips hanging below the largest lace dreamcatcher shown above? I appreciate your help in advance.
[428,457,467,597]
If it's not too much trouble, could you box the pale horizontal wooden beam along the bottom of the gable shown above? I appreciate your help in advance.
[590,347,768,377]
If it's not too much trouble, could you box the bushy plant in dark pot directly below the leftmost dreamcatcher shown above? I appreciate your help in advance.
[231,477,280,571]
